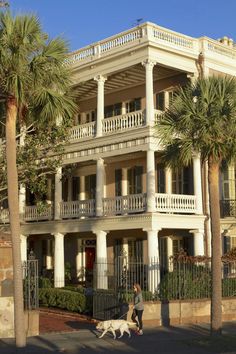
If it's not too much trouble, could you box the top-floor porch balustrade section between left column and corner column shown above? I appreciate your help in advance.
[103,111,144,134]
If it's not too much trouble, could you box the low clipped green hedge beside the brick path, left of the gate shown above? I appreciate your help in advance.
[39,288,86,313]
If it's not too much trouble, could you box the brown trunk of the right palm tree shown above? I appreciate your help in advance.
[208,159,222,335]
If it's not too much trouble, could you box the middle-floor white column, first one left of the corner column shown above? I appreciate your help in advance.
[96,158,104,216]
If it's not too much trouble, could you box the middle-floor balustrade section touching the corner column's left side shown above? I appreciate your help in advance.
[103,194,146,215]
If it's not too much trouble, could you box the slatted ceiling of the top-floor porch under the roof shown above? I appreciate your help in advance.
[76,64,178,100]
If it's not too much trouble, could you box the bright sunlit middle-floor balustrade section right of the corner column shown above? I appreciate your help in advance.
[155,193,197,214]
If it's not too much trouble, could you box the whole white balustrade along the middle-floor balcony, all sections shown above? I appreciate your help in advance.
[0,193,197,224]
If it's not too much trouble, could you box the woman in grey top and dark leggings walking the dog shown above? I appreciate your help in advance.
[131,283,144,336]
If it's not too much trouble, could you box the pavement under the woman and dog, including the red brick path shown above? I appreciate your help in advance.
[0,312,236,354]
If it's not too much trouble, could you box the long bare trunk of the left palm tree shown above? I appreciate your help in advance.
[6,98,26,347]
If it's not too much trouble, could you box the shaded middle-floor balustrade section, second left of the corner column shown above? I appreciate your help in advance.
[60,199,95,219]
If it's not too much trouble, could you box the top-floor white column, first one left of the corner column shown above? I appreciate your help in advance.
[94,75,106,137]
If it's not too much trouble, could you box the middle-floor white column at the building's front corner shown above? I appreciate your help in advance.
[146,150,156,213]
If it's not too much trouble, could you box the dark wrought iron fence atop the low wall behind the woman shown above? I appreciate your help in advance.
[93,257,236,301]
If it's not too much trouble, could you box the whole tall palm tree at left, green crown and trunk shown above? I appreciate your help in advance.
[0,12,75,347]
